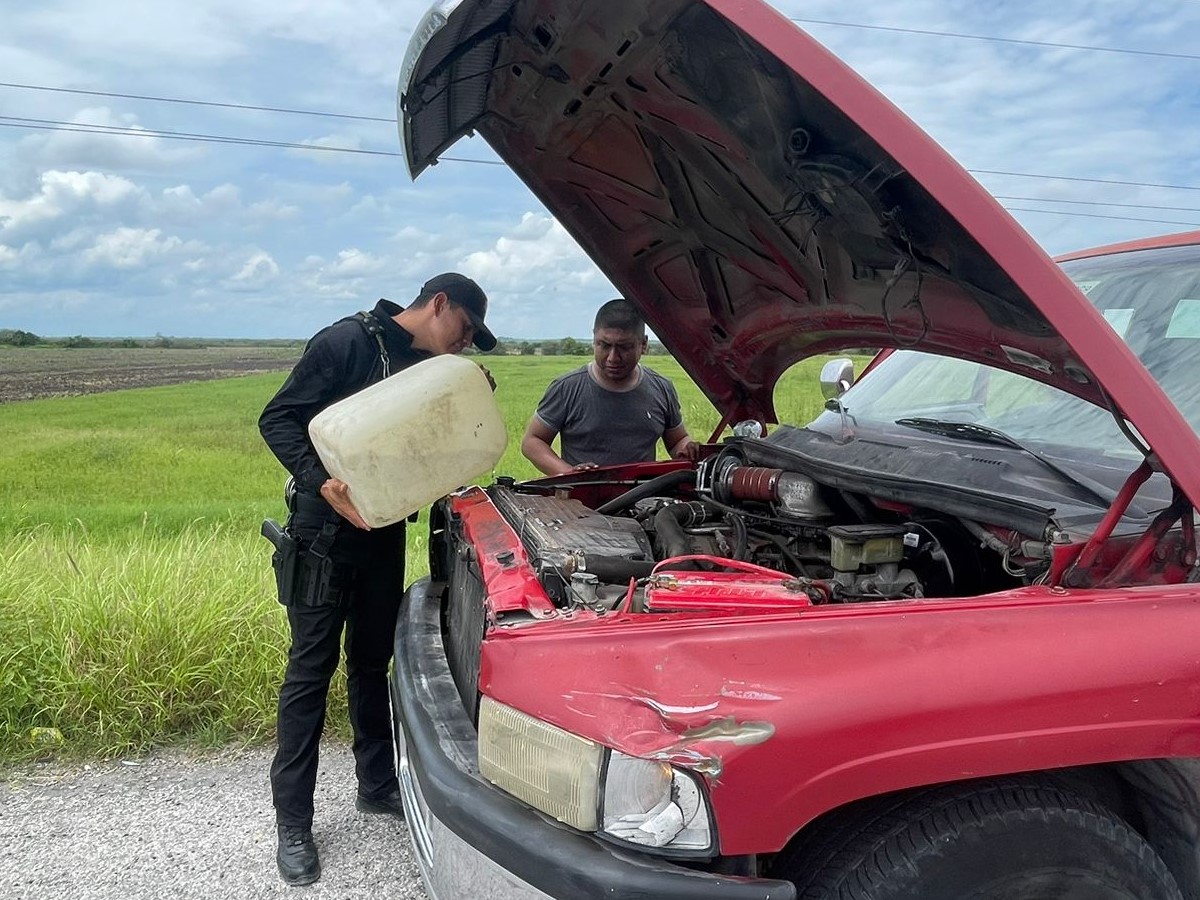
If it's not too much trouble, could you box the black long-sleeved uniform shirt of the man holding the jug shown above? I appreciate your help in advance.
[258,300,432,494]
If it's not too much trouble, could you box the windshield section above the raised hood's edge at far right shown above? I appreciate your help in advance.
[1062,245,1200,431]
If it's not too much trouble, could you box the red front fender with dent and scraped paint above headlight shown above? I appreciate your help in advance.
[479,595,1200,854]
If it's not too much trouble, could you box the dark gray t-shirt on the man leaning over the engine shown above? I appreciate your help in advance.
[536,366,683,466]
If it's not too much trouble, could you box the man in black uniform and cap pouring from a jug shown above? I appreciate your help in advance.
[258,272,496,884]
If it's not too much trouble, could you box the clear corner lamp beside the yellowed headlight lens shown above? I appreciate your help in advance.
[604,750,713,851]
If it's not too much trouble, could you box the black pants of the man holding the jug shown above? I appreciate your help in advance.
[271,504,404,827]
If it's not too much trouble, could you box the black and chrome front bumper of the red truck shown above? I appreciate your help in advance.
[392,578,796,900]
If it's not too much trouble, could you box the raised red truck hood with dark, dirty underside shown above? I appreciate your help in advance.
[398,0,1195,494]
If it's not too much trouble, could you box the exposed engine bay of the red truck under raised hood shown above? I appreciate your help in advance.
[487,444,1052,612]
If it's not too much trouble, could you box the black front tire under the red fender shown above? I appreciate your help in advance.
[774,779,1183,900]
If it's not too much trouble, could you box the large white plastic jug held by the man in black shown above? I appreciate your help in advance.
[308,355,508,528]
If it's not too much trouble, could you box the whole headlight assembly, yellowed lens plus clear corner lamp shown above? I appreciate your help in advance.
[479,696,713,854]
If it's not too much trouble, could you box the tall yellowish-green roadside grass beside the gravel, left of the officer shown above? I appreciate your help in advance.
[0,524,287,761]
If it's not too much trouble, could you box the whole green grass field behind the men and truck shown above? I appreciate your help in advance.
[0,350,844,762]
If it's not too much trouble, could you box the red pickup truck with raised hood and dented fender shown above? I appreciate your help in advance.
[394,0,1200,900]
